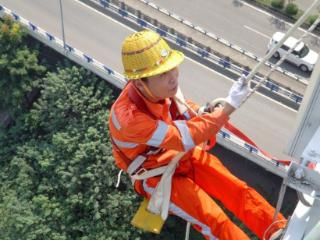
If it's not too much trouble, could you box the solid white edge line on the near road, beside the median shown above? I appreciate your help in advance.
[75,0,297,112]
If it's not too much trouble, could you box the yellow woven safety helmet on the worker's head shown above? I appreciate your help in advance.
[122,30,184,79]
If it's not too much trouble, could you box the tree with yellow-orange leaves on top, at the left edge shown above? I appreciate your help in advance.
[0,16,46,118]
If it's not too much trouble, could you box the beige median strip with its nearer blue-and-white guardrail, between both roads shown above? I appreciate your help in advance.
[80,0,307,96]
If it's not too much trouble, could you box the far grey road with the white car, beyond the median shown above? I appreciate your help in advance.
[152,0,320,78]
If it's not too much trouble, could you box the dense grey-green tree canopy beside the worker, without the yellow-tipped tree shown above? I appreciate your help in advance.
[0,67,148,240]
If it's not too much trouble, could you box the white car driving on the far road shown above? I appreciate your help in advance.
[268,32,318,72]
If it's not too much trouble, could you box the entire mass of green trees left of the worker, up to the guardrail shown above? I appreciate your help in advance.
[0,19,192,240]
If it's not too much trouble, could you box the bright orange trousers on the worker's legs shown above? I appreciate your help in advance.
[139,148,284,240]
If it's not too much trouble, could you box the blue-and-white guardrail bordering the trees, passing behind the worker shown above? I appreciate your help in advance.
[0,5,286,177]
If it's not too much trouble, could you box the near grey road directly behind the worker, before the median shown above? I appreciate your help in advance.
[0,0,297,158]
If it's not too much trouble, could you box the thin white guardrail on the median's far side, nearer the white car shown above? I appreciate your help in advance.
[139,0,307,85]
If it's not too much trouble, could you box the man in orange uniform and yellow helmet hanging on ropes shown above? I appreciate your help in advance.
[109,30,284,240]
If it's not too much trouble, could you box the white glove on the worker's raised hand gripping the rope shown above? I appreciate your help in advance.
[226,75,250,108]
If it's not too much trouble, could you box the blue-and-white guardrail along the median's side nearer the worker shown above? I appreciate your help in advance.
[80,0,305,106]
